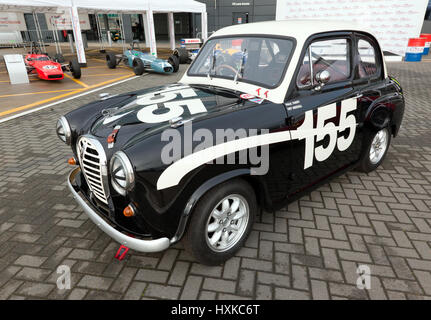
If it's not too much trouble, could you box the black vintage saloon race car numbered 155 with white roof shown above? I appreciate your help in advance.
[57,21,404,265]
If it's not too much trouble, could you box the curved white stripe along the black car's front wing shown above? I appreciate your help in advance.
[157,131,291,190]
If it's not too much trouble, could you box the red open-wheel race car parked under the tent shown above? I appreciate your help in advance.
[24,44,81,80]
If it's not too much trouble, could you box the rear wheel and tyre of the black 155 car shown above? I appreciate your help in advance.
[357,127,391,173]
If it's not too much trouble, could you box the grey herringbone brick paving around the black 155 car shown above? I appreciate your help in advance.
[0,62,431,299]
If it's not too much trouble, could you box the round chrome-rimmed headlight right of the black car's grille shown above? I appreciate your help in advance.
[111,151,135,196]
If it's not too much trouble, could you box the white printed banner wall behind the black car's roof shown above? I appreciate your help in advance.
[276,0,428,56]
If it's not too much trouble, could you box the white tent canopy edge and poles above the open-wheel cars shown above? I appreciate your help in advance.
[0,0,208,64]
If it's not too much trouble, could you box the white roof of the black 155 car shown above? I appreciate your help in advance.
[211,19,371,42]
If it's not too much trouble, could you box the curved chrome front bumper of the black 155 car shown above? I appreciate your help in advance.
[67,167,170,252]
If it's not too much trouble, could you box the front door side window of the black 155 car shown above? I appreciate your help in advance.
[296,38,351,89]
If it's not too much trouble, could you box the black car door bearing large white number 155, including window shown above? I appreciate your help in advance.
[285,33,361,197]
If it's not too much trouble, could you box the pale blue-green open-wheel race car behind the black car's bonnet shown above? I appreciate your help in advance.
[106,40,180,75]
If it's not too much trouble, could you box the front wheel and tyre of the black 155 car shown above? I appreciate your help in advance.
[184,179,258,265]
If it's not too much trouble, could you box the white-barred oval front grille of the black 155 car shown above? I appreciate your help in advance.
[76,136,109,204]
